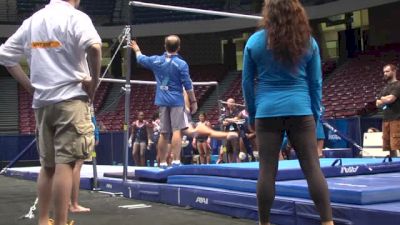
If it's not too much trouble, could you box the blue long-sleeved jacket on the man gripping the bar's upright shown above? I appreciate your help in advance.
[137,52,193,107]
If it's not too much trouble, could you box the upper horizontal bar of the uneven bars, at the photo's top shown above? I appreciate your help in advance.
[129,1,262,20]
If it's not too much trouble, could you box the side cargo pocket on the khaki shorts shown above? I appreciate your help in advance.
[74,123,94,159]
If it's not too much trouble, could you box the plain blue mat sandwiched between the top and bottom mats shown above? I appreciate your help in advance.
[168,173,400,205]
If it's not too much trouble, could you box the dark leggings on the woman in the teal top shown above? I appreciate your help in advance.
[256,116,332,224]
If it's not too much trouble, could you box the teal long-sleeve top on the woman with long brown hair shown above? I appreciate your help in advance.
[242,30,322,123]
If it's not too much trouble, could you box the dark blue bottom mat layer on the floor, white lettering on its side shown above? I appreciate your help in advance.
[120,178,400,225]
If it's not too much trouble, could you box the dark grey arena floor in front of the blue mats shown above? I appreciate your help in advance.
[0,176,257,225]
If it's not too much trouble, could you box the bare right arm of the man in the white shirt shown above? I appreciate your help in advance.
[83,44,101,102]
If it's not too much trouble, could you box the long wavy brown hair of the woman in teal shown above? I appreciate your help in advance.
[260,0,311,69]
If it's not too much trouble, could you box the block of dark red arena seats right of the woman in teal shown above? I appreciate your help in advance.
[323,44,400,118]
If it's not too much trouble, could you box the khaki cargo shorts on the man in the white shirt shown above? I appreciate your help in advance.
[35,97,95,167]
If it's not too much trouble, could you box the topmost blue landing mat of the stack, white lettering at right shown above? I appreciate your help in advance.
[133,158,400,182]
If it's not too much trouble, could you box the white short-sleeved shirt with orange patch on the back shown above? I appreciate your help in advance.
[0,0,101,108]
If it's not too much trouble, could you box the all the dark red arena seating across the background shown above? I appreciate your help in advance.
[15,44,400,133]
